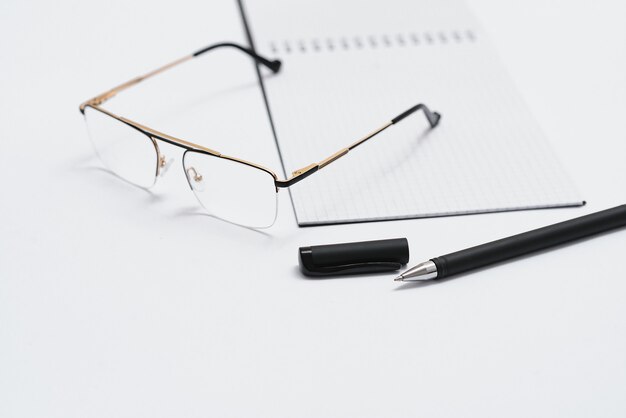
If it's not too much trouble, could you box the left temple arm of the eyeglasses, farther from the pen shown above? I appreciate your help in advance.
[80,42,281,113]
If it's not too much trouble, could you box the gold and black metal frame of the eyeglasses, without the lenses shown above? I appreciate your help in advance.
[79,42,441,192]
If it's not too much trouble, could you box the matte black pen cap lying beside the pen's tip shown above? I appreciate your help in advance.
[298,238,409,276]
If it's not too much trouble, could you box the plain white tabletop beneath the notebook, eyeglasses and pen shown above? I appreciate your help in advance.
[0,0,626,418]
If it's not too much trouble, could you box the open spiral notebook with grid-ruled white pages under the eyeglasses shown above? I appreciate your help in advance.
[242,0,583,225]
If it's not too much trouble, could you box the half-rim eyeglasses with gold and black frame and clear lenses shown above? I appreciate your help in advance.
[80,43,440,228]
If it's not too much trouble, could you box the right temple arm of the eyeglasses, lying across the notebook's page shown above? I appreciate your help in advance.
[276,103,441,187]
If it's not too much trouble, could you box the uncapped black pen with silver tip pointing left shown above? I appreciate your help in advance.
[395,205,626,282]
